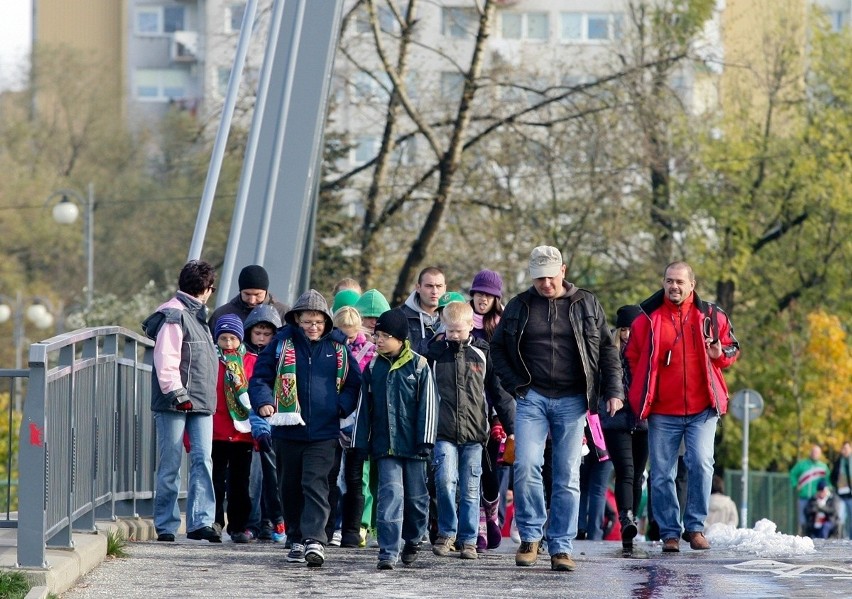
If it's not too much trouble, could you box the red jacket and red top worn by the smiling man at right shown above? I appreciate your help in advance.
[624,290,740,418]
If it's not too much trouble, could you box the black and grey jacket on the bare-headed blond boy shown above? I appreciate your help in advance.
[426,337,515,444]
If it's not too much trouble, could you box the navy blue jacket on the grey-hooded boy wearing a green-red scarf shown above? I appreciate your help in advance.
[249,324,361,441]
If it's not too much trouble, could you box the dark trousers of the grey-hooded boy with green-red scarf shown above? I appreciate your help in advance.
[273,438,340,545]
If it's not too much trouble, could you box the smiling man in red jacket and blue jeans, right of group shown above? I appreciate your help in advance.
[624,262,740,553]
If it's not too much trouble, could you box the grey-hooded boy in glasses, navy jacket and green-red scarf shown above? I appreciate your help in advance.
[249,289,361,567]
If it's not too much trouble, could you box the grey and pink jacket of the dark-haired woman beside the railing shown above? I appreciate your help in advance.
[142,291,219,414]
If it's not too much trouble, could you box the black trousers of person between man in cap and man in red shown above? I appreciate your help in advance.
[603,429,648,518]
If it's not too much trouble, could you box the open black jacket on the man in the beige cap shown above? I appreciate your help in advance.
[491,287,624,413]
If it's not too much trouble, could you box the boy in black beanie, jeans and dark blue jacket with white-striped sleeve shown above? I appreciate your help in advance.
[353,309,438,570]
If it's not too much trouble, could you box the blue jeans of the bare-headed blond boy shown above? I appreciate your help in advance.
[432,441,482,544]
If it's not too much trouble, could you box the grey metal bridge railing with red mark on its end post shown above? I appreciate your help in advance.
[18,326,156,568]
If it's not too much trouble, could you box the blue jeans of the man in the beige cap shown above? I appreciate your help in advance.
[514,389,587,555]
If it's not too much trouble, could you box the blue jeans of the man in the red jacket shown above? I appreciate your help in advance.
[648,408,719,540]
